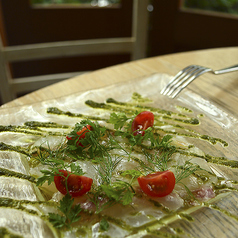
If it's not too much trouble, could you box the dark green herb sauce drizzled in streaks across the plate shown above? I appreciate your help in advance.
[0,94,238,237]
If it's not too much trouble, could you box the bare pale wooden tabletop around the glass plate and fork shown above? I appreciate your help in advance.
[2,47,238,117]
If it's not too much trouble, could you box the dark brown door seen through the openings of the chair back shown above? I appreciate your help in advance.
[0,0,133,77]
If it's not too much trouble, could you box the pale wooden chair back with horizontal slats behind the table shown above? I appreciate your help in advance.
[0,0,149,104]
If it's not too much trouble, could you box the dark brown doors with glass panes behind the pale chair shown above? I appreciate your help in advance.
[0,0,238,104]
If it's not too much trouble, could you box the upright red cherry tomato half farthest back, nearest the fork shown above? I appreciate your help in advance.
[131,111,154,136]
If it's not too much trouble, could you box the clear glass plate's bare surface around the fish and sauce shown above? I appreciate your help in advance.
[0,74,238,238]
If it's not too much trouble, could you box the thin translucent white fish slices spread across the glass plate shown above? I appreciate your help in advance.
[0,92,236,238]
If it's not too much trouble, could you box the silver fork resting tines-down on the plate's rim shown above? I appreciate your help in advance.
[160,65,238,98]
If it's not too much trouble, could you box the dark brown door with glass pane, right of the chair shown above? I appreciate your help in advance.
[149,0,238,56]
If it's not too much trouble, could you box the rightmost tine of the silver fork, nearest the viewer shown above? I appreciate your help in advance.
[170,66,212,98]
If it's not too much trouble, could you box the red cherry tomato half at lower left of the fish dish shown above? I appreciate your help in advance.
[54,170,93,197]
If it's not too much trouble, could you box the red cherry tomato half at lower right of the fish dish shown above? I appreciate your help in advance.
[137,170,175,197]
